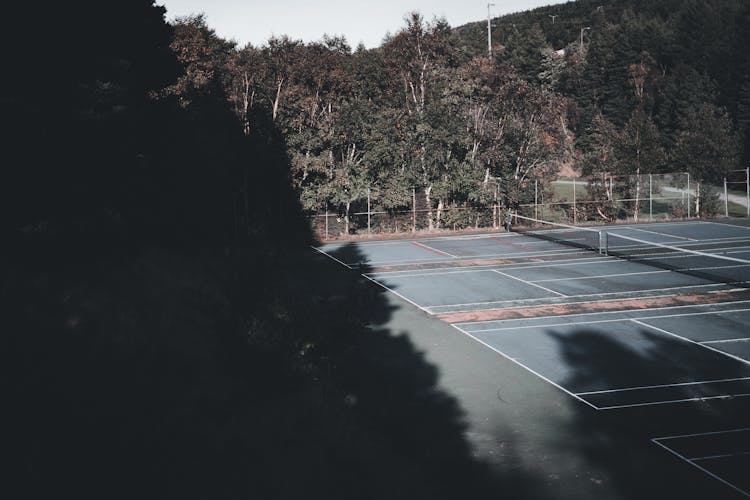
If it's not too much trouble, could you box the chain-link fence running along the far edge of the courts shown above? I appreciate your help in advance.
[310,169,750,239]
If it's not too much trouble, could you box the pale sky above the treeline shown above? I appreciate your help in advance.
[160,0,562,49]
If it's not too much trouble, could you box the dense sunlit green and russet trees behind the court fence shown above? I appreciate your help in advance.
[162,0,750,232]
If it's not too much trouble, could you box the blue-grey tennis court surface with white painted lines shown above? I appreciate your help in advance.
[318,221,750,497]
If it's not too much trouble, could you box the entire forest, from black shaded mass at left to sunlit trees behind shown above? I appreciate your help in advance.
[0,0,750,499]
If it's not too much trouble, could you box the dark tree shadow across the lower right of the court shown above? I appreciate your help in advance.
[549,328,750,498]
